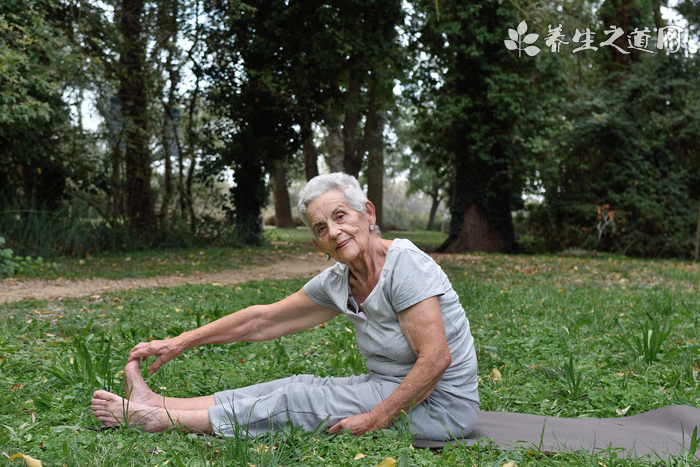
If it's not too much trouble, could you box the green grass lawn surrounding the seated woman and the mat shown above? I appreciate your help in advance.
[0,247,700,467]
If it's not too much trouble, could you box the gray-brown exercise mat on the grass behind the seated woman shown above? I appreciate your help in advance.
[413,405,700,459]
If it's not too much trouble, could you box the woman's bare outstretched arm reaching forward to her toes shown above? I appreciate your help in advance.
[129,289,340,374]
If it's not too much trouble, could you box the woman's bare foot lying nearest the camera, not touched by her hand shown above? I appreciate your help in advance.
[91,391,173,433]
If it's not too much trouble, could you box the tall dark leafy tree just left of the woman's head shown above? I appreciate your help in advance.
[205,0,306,244]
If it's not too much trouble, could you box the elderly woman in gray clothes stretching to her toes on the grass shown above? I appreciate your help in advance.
[92,173,479,440]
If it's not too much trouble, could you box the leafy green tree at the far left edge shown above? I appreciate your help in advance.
[0,0,75,210]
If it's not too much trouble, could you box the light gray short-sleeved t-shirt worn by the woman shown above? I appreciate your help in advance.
[304,239,479,406]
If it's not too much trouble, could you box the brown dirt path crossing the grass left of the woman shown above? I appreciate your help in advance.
[0,253,333,303]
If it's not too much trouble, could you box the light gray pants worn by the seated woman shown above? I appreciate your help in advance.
[209,375,478,441]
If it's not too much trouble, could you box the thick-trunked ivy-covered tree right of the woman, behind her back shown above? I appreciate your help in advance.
[414,0,534,252]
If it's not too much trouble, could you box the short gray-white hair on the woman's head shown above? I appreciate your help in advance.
[297,172,381,237]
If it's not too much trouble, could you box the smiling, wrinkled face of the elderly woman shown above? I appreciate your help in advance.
[306,191,374,263]
